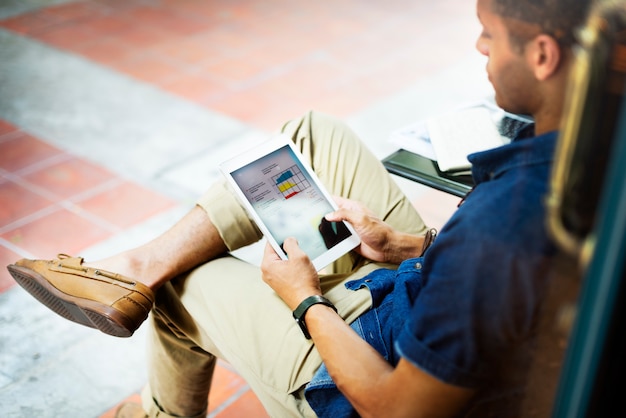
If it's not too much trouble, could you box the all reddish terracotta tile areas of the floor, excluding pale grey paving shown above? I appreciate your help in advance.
[0,0,476,417]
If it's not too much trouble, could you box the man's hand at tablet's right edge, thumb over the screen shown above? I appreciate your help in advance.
[326,197,424,264]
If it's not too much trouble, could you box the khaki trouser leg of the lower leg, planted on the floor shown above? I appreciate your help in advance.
[144,256,377,417]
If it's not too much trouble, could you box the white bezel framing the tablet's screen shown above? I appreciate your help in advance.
[219,135,360,271]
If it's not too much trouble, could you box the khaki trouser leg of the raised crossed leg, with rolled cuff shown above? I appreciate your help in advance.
[198,112,427,273]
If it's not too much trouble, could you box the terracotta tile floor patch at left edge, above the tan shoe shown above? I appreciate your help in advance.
[0,122,175,270]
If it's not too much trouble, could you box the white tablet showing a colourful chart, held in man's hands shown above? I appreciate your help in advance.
[220,136,360,271]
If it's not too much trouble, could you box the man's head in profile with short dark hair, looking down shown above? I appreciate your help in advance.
[476,0,590,133]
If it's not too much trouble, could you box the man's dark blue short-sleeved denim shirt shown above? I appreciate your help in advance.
[305,132,557,418]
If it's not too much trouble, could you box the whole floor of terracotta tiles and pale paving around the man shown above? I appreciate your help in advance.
[0,0,491,417]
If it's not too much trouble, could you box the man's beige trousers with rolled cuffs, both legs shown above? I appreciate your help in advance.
[143,113,426,418]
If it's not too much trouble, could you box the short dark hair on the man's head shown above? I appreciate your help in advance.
[492,0,594,47]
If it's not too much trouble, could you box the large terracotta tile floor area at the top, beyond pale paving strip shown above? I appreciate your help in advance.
[0,0,476,129]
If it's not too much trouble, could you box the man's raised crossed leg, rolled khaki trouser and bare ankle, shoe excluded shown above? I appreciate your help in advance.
[80,113,426,291]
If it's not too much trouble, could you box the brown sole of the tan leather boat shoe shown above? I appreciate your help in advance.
[7,264,137,337]
